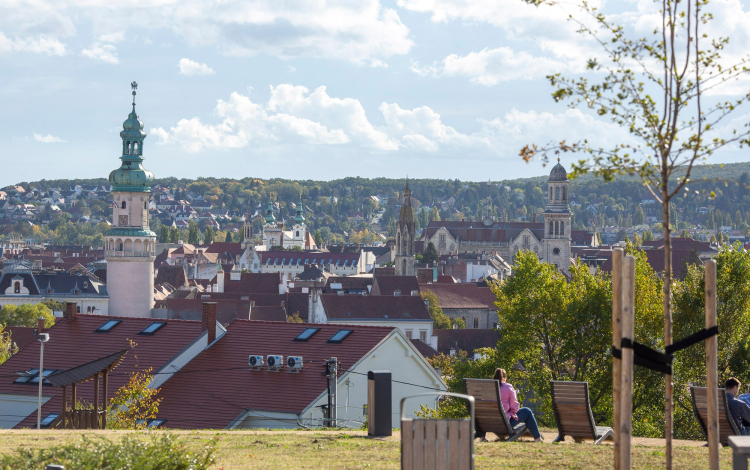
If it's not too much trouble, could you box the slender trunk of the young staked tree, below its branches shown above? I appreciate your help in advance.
[662,192,674,470]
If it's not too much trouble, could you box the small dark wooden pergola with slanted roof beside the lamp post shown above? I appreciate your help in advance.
[47,348,130,429]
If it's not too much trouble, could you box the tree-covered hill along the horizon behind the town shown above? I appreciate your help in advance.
[10,162,750,242]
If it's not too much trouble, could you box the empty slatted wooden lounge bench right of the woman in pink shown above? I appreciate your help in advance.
[550,380,615,444]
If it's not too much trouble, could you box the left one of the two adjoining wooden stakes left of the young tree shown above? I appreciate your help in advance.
[612,248,623,470]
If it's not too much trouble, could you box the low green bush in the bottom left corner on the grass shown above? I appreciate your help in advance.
[0,433,216,470]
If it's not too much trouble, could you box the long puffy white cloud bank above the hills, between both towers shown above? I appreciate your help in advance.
[151,84,630,161]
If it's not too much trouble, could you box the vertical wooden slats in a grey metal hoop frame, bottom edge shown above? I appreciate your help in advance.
[401,392,474,470]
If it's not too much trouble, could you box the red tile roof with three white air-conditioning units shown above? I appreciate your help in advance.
[158,320,394,429]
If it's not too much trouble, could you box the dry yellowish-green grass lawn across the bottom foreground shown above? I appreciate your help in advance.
[0,430,732,470]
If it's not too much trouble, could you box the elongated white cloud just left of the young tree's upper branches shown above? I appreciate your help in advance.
[411,47,568,86]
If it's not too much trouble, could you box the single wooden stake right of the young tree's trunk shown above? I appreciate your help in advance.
[705,260,719,470]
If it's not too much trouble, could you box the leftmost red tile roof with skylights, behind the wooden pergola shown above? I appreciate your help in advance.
[0,315,202,428]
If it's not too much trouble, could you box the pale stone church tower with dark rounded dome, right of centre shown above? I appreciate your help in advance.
[542,159,573,272]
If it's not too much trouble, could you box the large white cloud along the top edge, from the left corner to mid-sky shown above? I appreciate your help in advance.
[0,0,413,67]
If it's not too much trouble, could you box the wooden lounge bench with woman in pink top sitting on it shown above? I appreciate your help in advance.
[464,379,528,442]
